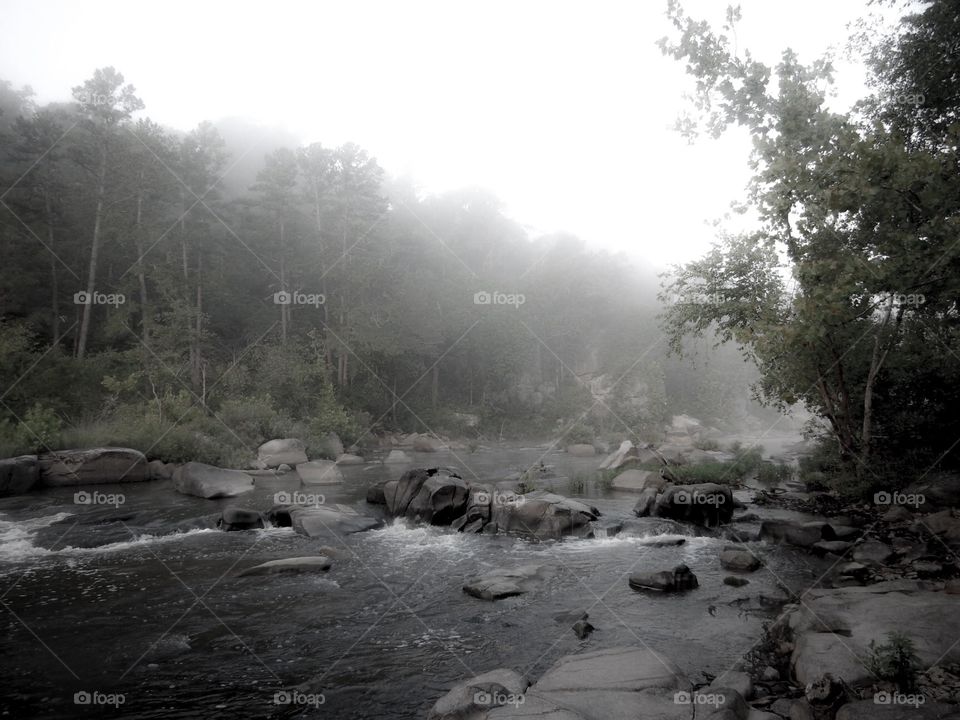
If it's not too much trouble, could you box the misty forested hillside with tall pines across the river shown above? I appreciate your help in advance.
[0,68,753,463]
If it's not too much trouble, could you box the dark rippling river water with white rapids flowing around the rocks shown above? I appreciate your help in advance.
[0,447,822,718]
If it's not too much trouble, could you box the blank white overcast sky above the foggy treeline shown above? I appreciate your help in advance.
[0,0,867,265]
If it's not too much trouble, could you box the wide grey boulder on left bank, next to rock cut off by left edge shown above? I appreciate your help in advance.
[39,447,149,487]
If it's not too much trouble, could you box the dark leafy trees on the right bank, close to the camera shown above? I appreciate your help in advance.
[662,0,960,487]
